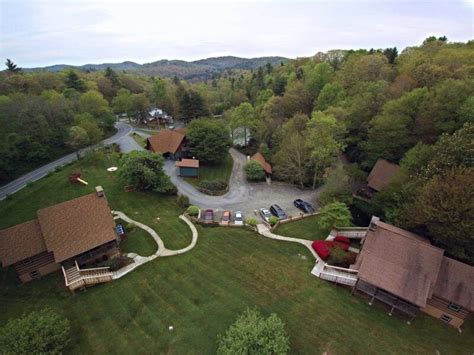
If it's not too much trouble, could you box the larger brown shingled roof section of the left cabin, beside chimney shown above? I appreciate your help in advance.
[38,193,116,262]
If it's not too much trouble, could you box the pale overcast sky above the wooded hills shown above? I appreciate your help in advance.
[0,0,474,67]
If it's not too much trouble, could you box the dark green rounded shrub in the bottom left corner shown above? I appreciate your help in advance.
[0,309,70,354]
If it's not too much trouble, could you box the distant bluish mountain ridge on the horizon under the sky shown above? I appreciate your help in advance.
[25,56,289,81]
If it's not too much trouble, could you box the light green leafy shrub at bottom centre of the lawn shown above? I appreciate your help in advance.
[217,309,290,355]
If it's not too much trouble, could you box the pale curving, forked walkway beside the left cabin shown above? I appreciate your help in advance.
[112,211,198,280]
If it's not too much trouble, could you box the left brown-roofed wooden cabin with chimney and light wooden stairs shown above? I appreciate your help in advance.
[0,187,120,291]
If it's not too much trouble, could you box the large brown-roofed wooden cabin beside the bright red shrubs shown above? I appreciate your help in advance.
[351,217,474,329]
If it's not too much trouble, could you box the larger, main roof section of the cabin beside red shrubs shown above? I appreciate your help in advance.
[356,221,444,307]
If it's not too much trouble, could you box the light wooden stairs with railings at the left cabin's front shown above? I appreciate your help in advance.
[62,261,113,291]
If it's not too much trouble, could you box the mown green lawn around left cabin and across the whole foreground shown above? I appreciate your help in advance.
[0,152,474,354]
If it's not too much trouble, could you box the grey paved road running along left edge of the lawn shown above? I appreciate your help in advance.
[0,122,133,200]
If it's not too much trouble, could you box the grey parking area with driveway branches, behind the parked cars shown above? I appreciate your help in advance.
[165,149,321,217]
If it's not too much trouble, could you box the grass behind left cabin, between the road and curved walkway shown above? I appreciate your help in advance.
[0,154,191,249]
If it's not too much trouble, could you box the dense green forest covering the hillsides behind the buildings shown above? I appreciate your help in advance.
[0,37,474,263]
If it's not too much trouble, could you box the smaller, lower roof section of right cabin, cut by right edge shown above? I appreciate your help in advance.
[433,257,474,311]
